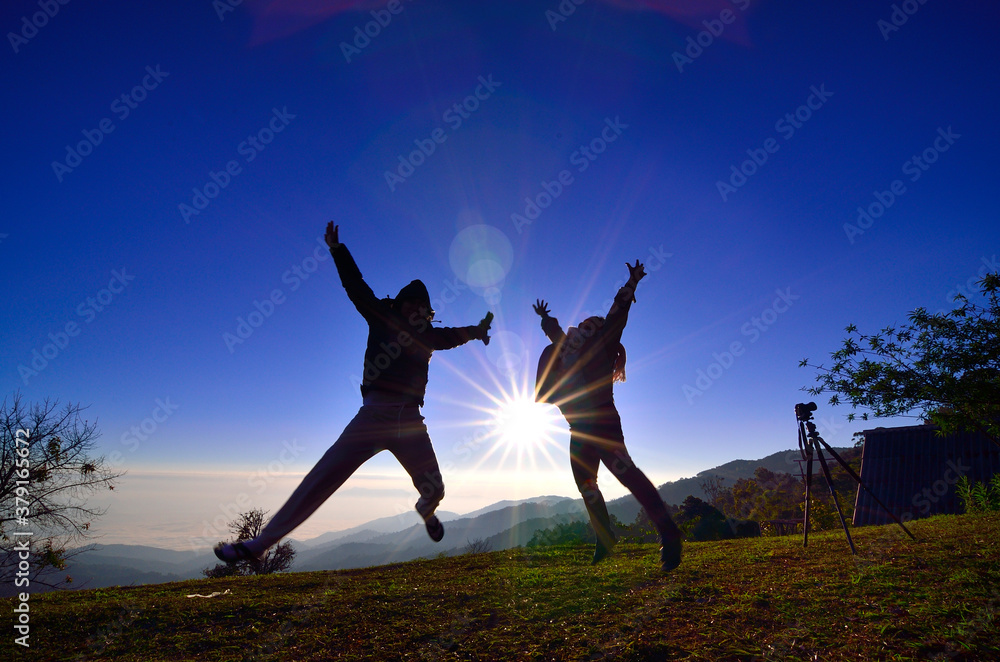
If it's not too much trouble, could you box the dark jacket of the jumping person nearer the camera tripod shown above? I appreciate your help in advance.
[535,287,633,419]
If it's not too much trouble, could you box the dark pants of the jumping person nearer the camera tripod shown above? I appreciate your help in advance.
[567,407,676,547]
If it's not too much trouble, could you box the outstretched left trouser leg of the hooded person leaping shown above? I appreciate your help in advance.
[254,407,384,553]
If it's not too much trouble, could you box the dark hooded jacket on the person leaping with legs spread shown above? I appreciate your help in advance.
[330,244,482,405]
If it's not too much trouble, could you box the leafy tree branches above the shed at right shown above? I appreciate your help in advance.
[799,273,1000,445]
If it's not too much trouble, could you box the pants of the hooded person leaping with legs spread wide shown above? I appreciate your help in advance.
[247,404,444,553]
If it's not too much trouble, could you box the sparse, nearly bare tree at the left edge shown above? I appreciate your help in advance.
[0,393,123,587]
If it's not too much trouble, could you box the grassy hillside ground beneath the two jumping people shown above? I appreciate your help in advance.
[7,514,1000,662]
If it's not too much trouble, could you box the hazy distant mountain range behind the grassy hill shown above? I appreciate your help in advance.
[41,449,828,588]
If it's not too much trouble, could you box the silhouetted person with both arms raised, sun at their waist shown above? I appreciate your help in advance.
[534,260,681,572]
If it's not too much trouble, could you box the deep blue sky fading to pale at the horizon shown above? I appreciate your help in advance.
[0,0,1000,549]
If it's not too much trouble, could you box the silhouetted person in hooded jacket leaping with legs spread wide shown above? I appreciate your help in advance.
[215,222,493,563]
